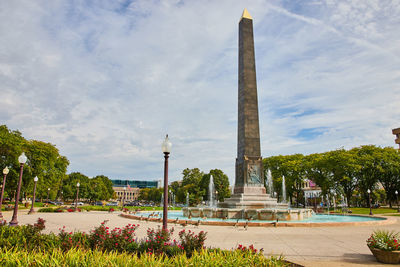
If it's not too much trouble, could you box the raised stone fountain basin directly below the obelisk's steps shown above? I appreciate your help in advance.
[182,207,313,221]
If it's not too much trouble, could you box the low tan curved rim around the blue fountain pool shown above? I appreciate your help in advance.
[120,210,397,227]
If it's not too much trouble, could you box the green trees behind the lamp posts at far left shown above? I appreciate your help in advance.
[0,125,114,203]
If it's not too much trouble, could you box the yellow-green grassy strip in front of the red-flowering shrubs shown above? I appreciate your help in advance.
[0,248,289,267]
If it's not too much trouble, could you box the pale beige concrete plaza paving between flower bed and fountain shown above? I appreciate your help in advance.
[3,210,400,267]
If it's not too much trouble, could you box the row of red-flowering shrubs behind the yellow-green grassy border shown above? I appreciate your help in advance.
[0,218,206,257]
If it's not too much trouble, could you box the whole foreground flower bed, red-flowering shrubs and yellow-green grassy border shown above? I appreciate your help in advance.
[0,218,286,266]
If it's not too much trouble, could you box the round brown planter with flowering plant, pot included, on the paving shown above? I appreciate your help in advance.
[367,230,400,263]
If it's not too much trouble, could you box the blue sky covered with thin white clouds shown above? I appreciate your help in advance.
[0,0,400,185]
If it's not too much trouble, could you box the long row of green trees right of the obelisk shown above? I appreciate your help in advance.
[263,145,400,206]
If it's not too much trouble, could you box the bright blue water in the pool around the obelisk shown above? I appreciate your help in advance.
[138,211,385,223]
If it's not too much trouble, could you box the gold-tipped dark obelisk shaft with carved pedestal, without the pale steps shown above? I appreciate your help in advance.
[235,9,265,193]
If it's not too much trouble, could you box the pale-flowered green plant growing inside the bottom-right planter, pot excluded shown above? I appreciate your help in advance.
[367,230,400,251]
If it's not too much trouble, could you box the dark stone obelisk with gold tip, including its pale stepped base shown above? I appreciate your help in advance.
[219,9,284,208]
